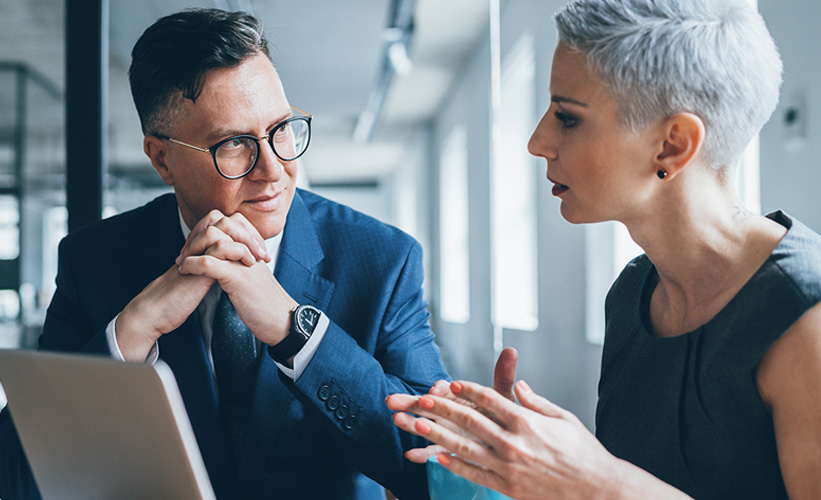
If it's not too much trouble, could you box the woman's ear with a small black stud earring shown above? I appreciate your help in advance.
[655,113,705,177]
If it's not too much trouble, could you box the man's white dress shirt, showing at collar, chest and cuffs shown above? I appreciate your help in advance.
[106,209,330,381]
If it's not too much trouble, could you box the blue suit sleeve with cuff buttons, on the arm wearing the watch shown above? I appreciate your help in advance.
[280,242,449,500]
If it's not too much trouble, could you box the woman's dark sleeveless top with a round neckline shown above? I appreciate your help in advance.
[596,211,821,500]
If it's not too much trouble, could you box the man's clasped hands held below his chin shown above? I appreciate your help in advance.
[115,210,297,360]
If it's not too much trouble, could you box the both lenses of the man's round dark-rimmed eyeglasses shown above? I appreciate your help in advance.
[214,118,310,177]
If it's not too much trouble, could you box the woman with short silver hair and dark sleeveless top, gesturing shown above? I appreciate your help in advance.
[388,0,821,499]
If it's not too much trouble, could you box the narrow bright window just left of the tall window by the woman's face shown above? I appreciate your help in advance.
[439,126,470,323]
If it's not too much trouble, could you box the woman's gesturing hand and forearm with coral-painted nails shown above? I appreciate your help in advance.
[387,381,689,500]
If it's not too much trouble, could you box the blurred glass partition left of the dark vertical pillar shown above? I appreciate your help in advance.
[0,63,65,347]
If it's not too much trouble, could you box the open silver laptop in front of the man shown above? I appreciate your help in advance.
[0,349,215,500]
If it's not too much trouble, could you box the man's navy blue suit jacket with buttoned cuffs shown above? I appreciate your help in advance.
[0,190,448,500]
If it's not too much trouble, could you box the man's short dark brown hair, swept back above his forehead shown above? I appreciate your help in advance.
[128,9,271,135]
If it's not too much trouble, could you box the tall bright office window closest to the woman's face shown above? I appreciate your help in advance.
[491,34,539,330]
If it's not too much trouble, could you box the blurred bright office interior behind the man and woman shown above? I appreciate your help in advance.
[0,0,821,427]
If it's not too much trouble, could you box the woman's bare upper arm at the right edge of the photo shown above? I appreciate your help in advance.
[757,304,821,500]
